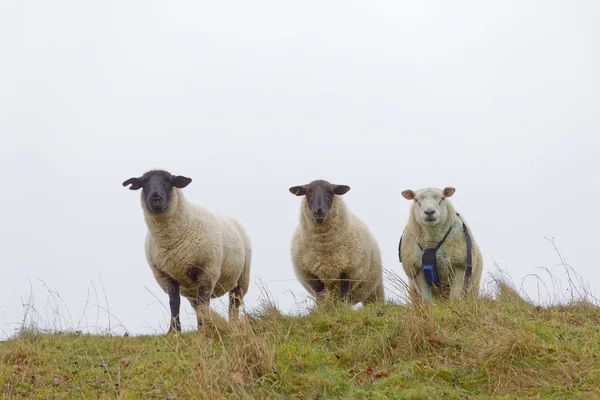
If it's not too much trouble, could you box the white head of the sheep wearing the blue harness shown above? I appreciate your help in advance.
[402,187,456,226]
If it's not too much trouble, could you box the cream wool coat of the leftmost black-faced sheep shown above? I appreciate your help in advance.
[142,188,252,318]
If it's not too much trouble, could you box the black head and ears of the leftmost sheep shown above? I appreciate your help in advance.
[123,171,192,213]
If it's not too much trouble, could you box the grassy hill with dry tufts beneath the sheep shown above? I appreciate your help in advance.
[0,287,600,399]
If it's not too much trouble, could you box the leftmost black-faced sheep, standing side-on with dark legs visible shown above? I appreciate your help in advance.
[123,170,252,332]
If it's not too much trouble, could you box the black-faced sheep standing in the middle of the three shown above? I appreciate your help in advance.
[289,180,384,306]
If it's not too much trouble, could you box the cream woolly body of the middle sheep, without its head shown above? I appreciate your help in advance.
[292,196,384,304]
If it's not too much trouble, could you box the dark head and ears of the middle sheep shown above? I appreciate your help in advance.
[290,180,350,224]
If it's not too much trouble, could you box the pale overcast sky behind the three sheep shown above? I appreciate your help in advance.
[0,0,600,337]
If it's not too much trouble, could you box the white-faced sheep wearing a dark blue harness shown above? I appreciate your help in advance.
[399,187,483,304]
